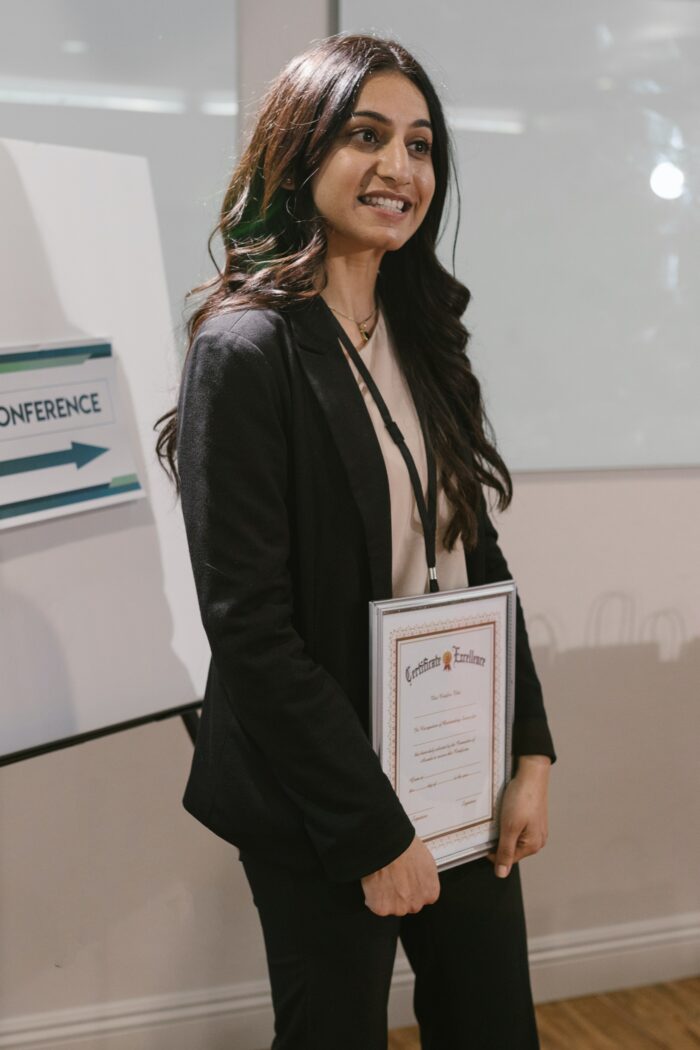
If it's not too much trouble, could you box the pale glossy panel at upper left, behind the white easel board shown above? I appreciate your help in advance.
[0,0,238,342]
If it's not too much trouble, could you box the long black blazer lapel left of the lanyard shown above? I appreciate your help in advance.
[287,295,391,601]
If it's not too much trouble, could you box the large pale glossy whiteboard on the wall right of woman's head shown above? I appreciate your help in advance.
[340,0,700,471]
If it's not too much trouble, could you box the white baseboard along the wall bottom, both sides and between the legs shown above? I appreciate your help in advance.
[0,912,700,1050]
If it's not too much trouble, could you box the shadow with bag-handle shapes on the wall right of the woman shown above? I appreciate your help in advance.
[529,593,700,932]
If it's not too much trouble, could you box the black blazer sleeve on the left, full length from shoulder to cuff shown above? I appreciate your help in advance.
[177,329,416,882]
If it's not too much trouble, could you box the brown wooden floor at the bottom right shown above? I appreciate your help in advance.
[388,978,700,1050]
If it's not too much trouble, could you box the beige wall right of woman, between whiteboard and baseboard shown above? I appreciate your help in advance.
[501,470,700,940]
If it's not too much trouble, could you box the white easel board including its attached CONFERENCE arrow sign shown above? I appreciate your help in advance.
[0,139,210,757]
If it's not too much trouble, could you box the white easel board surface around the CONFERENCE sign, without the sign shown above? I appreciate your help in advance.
[0,139,209,756]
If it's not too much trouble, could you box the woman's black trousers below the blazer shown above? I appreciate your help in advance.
[240,853,539,1050]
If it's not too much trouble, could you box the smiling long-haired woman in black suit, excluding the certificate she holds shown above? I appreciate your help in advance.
[157,28,555,1050]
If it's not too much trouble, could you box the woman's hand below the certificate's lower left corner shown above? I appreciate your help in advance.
[360,835,440,916]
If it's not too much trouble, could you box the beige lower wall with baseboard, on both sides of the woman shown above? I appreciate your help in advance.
[0,470,700,1050]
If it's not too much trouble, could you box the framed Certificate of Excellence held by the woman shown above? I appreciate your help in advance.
[369,581,515,870]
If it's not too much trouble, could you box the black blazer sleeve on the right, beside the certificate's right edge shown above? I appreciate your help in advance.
[482,506,556,762]
